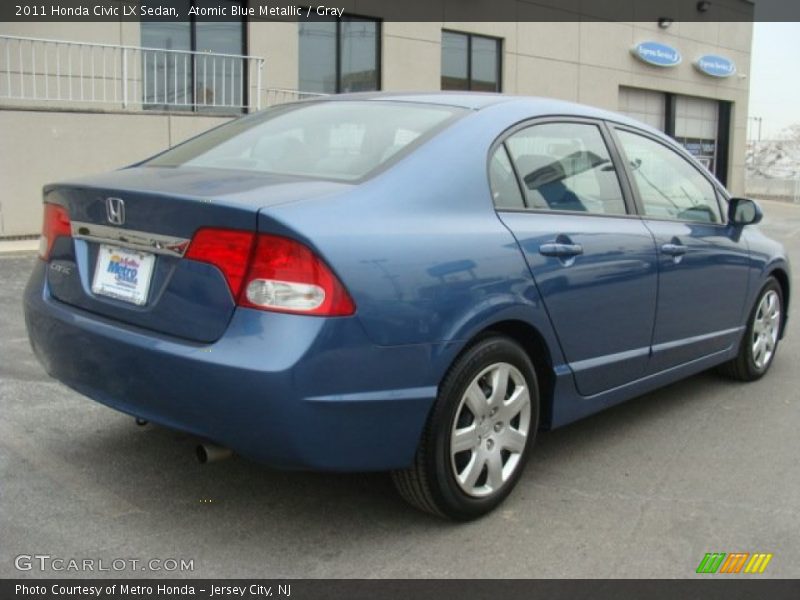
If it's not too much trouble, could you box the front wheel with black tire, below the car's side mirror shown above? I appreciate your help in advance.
[718,277,783,381]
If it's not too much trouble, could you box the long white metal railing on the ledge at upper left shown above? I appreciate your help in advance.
[0,35,268,113]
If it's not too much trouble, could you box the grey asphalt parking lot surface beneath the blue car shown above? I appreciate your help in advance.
[0,203,800,578]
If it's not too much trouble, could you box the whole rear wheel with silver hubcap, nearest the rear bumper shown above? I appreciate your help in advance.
[392,335,539,521]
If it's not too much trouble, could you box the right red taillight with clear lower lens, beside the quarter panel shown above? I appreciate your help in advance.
[186,229,355,317]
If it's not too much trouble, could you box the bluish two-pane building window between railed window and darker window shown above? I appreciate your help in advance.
[299,16,380,94]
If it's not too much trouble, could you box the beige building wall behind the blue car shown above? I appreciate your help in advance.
[0,19,752,236]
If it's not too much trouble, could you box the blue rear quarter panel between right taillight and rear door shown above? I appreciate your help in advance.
[259,102,561,374]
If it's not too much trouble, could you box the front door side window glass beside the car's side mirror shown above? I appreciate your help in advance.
[618,131,722,223]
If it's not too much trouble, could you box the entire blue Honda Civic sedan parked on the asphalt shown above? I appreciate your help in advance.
[25,93,790,520]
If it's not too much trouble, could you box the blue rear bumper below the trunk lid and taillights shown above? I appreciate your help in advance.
[24,261,441,471]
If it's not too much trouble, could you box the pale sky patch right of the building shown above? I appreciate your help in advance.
[748,22,800,140]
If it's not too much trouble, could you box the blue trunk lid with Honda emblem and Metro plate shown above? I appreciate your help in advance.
[45,167,350,343]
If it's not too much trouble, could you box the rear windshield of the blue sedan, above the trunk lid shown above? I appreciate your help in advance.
[145,100,466,181]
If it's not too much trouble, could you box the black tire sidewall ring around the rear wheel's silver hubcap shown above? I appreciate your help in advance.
[426,336,539,520]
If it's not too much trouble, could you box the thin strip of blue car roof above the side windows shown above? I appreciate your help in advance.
[314,92,663,136]
